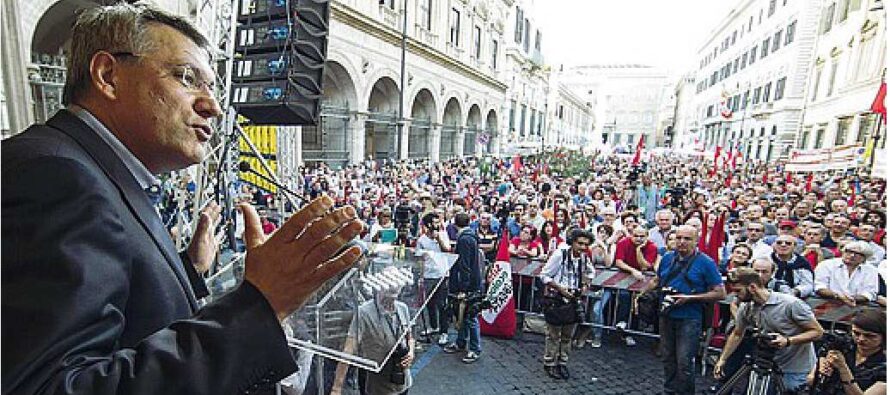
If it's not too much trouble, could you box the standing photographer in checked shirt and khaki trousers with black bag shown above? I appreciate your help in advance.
[541,229,594,379]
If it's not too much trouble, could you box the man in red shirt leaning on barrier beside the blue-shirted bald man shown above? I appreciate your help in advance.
[615,226,661,347]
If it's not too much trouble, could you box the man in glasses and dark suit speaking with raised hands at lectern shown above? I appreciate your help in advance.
[2,3,363,394]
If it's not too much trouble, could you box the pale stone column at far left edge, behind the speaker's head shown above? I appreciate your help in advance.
[0,0,34,137]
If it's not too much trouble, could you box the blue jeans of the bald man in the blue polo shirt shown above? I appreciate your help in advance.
[659,317,701,394]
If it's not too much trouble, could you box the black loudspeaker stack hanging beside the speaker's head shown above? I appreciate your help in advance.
[232,0,330,125]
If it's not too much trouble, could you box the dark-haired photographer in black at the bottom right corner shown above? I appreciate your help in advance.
[807,308,887,395]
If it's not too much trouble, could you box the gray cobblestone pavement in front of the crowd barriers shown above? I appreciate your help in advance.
[410,333,713,395]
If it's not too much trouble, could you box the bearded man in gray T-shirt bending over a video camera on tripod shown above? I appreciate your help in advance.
[714,268,822,390]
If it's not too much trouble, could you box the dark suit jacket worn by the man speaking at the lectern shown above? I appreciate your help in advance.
[0,110,296,394]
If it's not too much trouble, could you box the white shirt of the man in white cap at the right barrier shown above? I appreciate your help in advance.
[816,258,878,301]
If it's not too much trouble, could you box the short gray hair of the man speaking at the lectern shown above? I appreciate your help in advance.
[62,2,210,105]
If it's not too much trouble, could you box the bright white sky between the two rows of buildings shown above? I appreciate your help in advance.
[534,0,738,73]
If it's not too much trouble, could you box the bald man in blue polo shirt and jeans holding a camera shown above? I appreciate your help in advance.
[651,225,726,394]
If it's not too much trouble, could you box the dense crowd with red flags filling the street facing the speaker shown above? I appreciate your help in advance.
[220,150,886,393]
